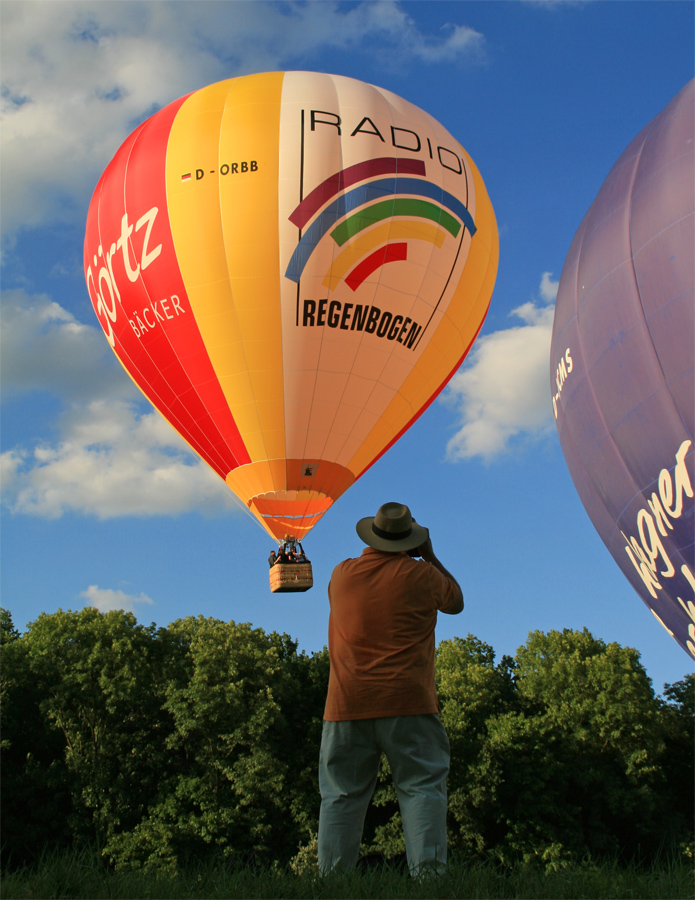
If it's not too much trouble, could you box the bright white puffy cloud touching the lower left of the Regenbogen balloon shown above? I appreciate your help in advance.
[0,400,238,519]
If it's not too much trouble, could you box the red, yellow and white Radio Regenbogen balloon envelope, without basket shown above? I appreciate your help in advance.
[84,72,498,539]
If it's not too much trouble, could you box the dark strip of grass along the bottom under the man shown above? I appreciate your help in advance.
[1,853,694,900]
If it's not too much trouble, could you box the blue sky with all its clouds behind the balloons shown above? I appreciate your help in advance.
[0,0,695,692]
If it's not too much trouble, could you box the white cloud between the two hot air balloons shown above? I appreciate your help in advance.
[443,272,558,461]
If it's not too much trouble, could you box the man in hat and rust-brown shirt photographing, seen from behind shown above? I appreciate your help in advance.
[318,503,463,875]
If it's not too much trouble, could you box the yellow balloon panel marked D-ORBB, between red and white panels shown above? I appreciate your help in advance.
[167,73,286,468]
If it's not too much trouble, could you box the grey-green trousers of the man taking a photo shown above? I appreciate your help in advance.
[318,714,449,874]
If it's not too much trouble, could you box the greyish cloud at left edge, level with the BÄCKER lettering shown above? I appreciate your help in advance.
[0,290,137,400]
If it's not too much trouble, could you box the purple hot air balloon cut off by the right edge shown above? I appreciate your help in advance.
[550,81,695,657]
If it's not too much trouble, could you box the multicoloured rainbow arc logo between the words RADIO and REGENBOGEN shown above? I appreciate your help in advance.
[285,157,476,291]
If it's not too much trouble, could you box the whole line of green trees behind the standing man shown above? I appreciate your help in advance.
[0,607,695,869]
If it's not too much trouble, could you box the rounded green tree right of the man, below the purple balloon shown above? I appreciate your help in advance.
[502,629,664,863]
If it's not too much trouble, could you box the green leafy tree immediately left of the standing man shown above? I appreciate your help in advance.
[108,617,325,868]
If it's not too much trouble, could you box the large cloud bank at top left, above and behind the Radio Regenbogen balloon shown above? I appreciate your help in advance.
[0,0,483,236]
